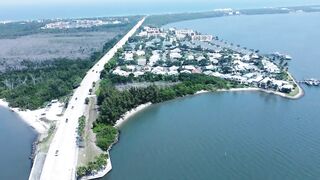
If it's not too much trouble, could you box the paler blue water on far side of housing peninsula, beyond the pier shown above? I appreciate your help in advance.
[165,13,320,80]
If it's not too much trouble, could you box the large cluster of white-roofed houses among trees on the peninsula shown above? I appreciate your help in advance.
[112,27,294,93]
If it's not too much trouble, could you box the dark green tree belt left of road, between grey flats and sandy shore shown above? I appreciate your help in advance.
[0,35,122,110]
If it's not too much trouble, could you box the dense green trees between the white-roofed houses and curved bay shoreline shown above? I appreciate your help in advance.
[94,71,239,150]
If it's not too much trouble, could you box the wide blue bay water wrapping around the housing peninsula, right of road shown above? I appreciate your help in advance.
[103,14,320,180]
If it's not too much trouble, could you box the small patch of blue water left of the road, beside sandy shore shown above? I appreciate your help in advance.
[0,107,36,180]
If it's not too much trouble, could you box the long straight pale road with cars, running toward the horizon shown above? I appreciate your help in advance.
[40,18,145,180]
